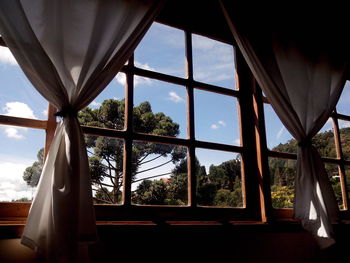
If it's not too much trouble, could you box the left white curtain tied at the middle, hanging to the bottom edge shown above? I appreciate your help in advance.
[0,0,163,262]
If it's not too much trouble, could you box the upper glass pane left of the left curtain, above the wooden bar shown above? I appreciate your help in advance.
[0,47,48,119]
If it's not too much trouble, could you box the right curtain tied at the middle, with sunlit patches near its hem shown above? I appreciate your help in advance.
[221,0,348,247]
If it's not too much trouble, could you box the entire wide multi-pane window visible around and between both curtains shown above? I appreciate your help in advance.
[0,23,350,221]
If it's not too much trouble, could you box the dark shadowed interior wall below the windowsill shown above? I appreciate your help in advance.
[0,225,349,263]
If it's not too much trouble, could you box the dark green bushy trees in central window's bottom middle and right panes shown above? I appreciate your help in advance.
[133,159,243,207]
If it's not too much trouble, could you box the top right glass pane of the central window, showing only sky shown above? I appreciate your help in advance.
[192,34,236,89]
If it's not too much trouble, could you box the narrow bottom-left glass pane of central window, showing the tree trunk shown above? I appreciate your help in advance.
[85,135,124,204]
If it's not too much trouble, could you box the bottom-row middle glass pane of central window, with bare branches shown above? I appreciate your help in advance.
[132,141,188,205]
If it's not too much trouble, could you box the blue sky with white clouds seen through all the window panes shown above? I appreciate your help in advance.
[0,23,350,201]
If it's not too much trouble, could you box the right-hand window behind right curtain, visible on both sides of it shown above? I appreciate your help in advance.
[263,81,350,218]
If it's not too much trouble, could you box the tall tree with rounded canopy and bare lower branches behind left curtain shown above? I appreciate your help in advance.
[23,99,185,203]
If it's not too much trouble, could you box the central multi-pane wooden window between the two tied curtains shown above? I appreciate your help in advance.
[79,23,259,220]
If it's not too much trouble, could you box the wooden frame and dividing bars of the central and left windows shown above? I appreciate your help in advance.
[0,26,268,223]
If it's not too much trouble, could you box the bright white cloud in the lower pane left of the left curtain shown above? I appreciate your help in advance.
[0,160,35,201]
